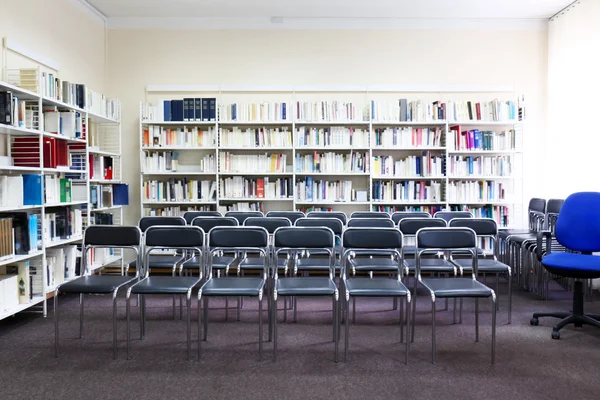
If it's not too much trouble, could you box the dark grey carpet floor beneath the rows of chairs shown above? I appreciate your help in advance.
[0,286,600,400]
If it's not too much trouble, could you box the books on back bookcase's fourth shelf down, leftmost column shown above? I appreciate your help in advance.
[142,178,217,201]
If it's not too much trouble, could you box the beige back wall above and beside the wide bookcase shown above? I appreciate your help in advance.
[108,30,547,223]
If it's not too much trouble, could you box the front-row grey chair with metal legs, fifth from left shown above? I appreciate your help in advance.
[340,228,410,363]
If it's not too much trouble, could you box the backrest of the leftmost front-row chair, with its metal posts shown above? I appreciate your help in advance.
[79,225,142,276]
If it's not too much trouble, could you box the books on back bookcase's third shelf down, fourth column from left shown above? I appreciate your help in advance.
[373,151,446,177]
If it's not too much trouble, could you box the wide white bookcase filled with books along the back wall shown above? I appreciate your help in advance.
[139,85,524,227]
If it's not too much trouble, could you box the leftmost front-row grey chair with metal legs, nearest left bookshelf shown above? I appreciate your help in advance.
[54,225,142,359]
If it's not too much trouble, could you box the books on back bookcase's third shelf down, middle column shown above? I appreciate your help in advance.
[296,151,370,173]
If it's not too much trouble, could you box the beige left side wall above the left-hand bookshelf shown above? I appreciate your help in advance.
[0,0,106,92]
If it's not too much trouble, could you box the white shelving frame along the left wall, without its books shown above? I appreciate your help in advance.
[0,36,123,320]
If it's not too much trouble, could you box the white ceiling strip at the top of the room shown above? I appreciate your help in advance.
[87,0,573,20]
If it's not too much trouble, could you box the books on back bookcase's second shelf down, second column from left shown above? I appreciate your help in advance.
[221,127,293,147]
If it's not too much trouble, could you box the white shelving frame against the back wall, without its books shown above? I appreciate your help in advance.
[139,85,524,222]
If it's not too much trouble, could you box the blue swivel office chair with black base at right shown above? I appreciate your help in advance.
[530,192,600,339]
